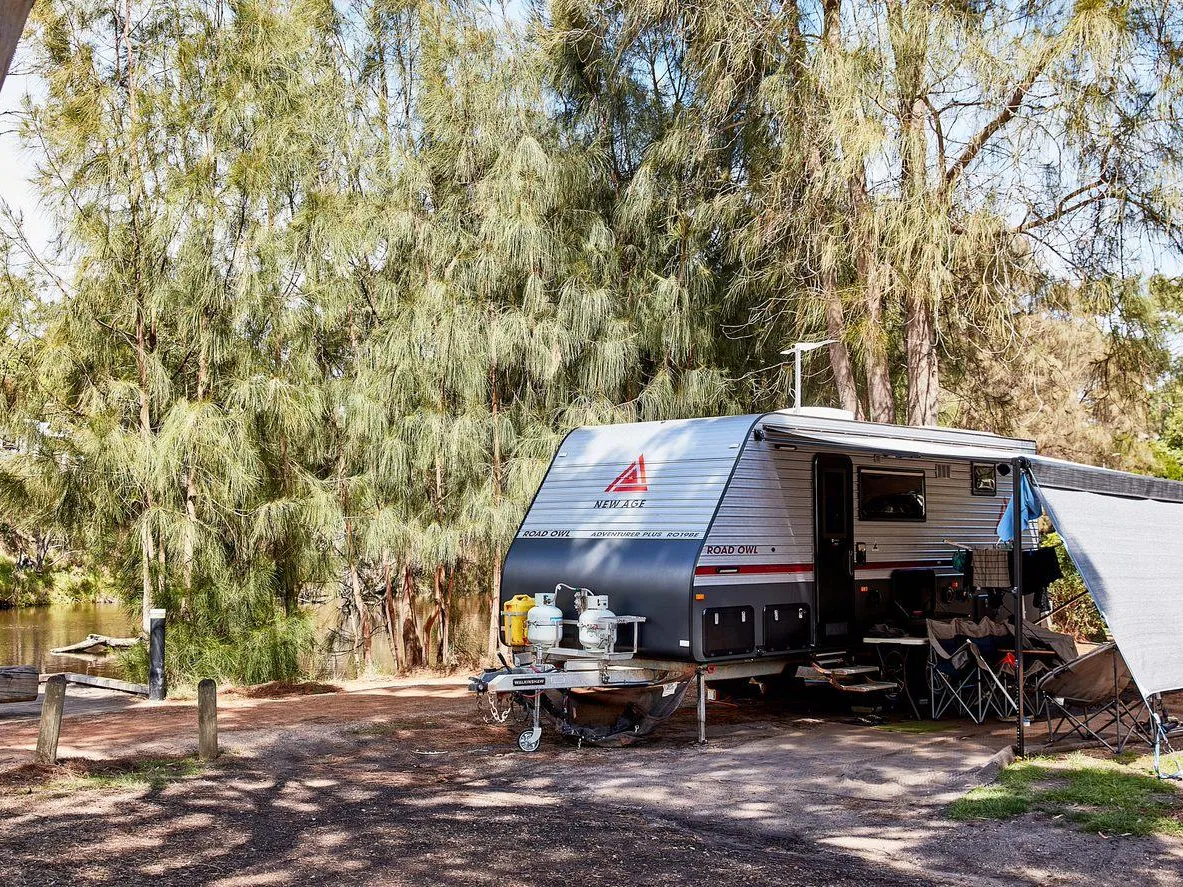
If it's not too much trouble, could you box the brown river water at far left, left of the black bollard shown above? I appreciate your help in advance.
[0,603,140,678]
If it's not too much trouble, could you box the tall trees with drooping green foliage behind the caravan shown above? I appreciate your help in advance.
[0,0,1183,680]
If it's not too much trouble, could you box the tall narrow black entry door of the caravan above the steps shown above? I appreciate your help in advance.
[814,453,854,647]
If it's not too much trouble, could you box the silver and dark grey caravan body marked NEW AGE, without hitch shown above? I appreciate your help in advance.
[502,410,1035,663]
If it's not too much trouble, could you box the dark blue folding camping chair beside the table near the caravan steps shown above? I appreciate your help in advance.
[927,619,1016,724]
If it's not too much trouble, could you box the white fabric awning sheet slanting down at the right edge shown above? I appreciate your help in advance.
[1027,457,1183,697]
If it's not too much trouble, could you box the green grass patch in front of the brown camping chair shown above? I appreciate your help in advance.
[948,752,1183,835]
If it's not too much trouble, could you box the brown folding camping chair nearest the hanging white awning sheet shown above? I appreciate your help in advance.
[1037,643,1155,755]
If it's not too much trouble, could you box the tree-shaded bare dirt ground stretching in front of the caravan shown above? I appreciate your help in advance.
[0,679,1183,887]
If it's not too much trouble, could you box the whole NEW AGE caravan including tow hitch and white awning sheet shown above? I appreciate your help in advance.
[472,409,1183,749]
